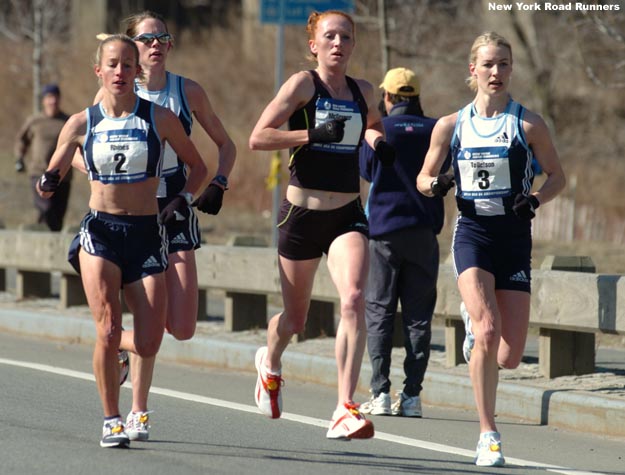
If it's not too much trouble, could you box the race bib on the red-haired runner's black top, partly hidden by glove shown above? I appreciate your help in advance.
[310,97,362,153]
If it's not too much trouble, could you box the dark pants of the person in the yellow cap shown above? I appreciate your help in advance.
[365,228,439,397]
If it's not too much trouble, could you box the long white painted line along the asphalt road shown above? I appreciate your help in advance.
[0,358,606,475]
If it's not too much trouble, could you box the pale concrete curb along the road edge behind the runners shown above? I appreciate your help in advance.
[0,309,625,437]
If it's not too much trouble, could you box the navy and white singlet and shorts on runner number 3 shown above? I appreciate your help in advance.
[451,100,534,292]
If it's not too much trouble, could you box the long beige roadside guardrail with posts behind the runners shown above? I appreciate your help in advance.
[0,230,625,377]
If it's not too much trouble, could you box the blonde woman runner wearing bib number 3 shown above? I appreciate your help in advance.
[417,32,565,466]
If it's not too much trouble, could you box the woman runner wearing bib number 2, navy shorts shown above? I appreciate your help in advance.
[37,35,206,447]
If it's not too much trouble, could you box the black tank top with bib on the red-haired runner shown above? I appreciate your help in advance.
[289,70,368,193]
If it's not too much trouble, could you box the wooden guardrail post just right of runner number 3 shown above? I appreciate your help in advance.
[538,256,596,378]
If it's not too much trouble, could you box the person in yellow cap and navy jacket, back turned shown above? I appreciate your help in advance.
[360,68,449,417]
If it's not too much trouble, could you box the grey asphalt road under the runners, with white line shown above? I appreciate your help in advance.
[0,333,625,475]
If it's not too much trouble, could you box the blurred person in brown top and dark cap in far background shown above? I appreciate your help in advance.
[15,84,72,231]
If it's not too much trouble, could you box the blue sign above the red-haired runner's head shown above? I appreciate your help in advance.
[260,0,354,25]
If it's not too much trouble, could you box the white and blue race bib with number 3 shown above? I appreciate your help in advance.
[457,147,511,200]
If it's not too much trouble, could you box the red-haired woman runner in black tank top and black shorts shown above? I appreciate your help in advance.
[250,11,394,439]
